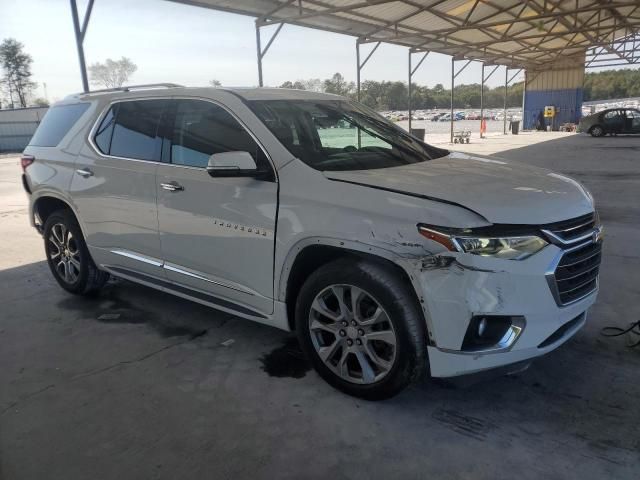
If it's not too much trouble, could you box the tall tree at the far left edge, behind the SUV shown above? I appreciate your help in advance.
[0,38,36,107]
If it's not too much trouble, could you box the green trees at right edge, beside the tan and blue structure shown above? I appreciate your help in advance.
[584,69,640,101]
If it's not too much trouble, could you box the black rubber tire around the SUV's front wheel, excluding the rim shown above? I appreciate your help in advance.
[295,259,428,400]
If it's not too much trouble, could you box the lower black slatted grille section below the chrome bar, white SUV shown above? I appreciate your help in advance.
[553,242,602,305]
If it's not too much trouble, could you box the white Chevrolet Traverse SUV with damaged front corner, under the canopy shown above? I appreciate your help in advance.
[22,85,602,399]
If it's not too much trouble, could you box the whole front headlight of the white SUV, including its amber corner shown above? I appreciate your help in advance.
[418,225,548,260]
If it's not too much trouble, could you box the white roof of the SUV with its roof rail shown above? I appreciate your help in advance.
[60,84,345,103]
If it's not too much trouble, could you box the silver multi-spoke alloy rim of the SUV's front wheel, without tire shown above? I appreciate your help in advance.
[309,285,398,384]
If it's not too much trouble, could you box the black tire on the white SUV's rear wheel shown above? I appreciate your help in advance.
[43,210,109,295]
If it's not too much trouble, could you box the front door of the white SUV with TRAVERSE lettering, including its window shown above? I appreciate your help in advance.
[157,99,278,314]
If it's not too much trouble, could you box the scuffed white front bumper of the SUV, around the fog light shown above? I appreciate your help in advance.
[418,245,597,377]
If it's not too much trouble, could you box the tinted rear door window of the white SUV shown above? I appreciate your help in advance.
[109,100,167,161]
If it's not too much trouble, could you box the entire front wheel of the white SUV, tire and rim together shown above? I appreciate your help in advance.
[296,259,427,400]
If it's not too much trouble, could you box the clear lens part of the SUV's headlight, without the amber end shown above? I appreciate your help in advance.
[453,235,548,260]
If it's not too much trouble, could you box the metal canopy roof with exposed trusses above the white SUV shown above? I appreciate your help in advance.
[169,0,640,70]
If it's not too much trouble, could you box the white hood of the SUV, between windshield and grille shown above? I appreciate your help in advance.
[324,152,593,225]
